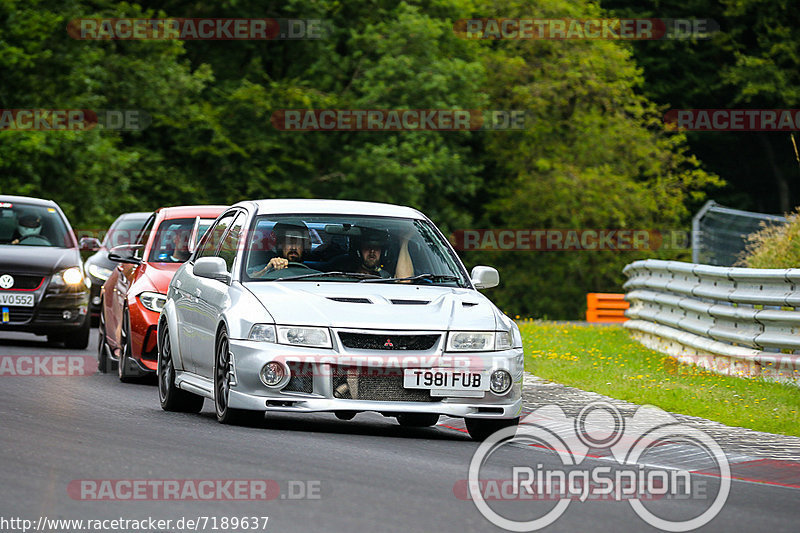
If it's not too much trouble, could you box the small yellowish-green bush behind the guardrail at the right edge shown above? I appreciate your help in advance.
[739,208,800,268]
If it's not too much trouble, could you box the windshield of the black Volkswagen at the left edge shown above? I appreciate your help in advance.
[0,202,73,248]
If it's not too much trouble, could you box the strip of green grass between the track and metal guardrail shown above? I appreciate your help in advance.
[518,321,800,436]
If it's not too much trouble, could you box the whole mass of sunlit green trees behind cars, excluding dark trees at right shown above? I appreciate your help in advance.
[0,0,720,318]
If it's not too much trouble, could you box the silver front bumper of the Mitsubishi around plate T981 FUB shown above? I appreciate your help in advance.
[228,339,523,418]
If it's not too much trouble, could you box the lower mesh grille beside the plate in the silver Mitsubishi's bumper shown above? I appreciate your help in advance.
[331,365,441,402]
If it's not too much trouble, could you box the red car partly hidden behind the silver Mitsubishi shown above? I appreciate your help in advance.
[97,205,226,382]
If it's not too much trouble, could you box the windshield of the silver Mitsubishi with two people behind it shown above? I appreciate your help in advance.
[242,214,469,287]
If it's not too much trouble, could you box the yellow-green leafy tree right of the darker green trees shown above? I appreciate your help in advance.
[467,0,721,318]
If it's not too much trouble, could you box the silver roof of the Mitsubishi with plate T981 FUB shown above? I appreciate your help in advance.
[236,198,425,219]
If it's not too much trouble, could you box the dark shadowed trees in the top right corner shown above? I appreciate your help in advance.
[601,0,800,213]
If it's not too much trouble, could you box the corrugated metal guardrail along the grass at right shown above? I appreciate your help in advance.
[623,259,800,385]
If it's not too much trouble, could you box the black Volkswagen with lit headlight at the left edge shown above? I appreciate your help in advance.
[0,195,92,348]
